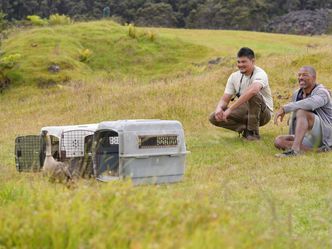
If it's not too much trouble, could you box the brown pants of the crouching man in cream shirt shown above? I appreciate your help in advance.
[209,94,271,133]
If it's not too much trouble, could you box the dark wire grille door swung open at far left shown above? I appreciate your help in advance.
[15,136,41,171]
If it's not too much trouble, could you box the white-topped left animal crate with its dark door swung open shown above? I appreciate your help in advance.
[15,124,97,174]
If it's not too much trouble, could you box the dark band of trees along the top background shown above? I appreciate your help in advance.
[0,0,332,31]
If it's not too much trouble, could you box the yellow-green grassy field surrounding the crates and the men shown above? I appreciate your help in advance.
[0,22,332,248]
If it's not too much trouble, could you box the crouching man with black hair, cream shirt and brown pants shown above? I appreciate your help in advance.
[209,48,273,141]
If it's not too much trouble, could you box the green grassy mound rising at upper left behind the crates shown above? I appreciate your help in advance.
[4,21,211,86]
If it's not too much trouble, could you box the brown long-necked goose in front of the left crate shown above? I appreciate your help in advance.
[42,131,72,183]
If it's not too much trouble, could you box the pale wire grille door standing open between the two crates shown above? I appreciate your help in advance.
[61,130,94,158]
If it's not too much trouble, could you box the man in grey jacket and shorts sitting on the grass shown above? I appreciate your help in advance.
[274,66,332,157]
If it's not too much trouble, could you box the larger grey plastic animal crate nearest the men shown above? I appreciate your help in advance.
[92,120,187,185]
